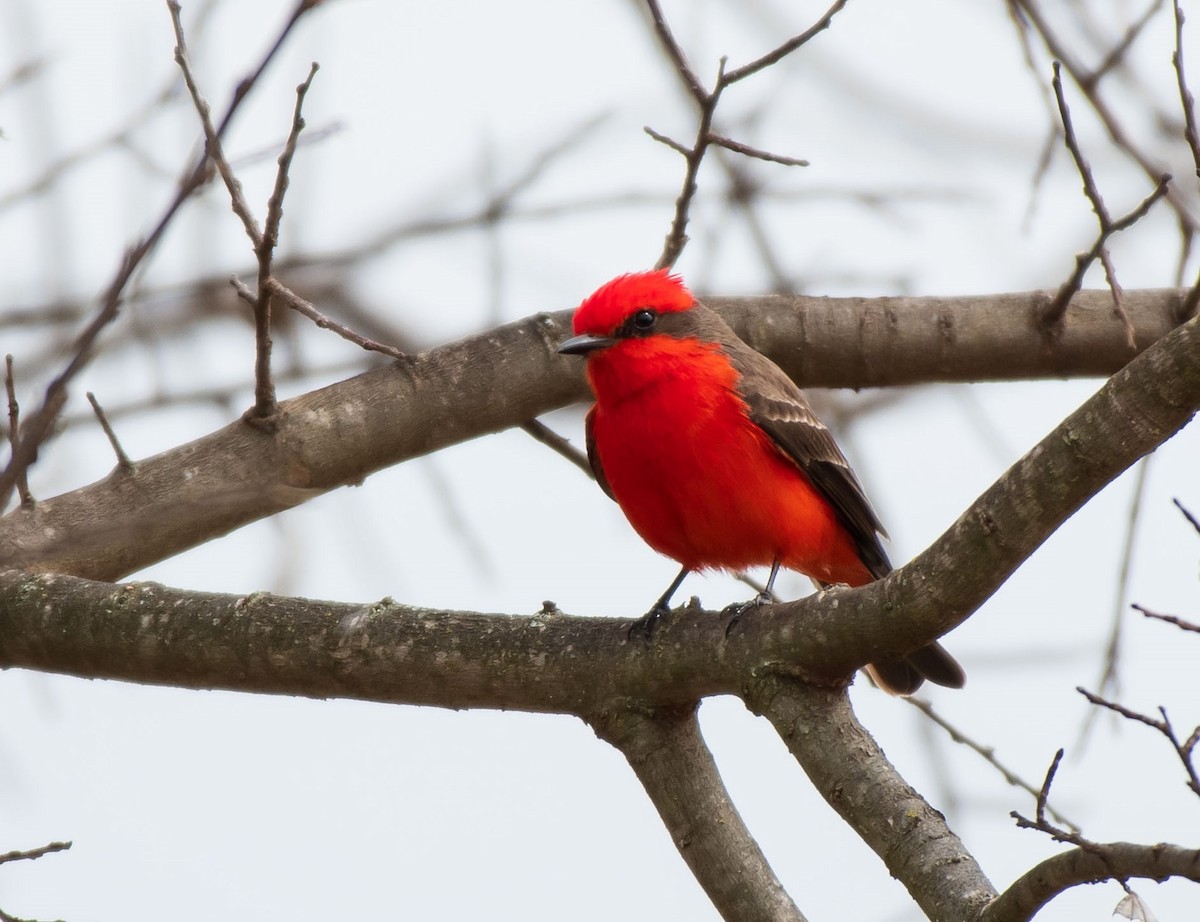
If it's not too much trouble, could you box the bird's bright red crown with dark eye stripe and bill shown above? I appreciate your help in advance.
[558,269,696,355]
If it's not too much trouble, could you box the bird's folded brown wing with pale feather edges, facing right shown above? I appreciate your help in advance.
[722,339,892,579]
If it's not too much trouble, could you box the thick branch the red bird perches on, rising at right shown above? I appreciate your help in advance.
[0,309,1200,714]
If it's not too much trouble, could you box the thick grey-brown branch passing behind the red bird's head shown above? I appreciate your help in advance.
[0,289,1182,580]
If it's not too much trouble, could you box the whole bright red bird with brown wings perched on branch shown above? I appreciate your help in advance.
[558,270,966,695]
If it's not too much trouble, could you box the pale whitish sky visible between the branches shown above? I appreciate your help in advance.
[0,0,1200,922]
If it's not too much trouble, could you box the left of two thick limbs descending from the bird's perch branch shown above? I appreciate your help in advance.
[588,705,804,922]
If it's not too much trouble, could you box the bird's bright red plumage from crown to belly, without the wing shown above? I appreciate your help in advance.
[575,273,874,586]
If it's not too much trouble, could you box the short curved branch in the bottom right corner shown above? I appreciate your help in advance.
[979,842,1200,922]
